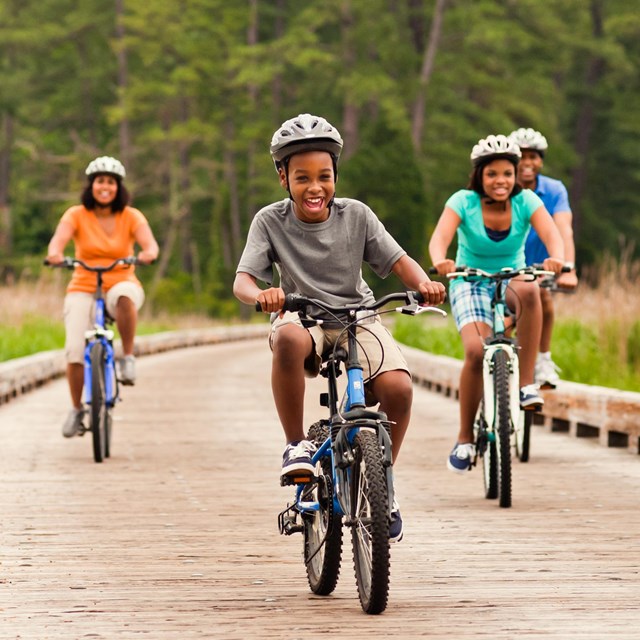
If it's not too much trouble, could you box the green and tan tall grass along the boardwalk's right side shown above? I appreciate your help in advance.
[394,251,640,391]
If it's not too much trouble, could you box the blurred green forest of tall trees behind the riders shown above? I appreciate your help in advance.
[0,0,640,388]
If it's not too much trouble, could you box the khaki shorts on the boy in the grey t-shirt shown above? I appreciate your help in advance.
[269,311,411,381]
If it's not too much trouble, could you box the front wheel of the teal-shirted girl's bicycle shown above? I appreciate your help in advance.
[493,350,511,508]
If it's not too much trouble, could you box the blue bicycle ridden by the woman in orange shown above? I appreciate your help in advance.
[45,257,141,462]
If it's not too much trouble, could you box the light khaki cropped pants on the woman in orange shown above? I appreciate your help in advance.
[64,282,144,364]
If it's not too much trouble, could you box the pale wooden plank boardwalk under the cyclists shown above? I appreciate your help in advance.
[0,340,640,640]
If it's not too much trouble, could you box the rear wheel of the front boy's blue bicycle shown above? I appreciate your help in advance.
[302,423,342,596]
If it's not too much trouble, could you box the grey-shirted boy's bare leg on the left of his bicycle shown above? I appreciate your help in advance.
[271,324,313,442]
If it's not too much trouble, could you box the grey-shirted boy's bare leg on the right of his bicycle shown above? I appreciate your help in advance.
[371,369,413,464]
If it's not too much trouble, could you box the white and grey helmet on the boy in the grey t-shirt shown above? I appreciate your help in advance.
[269,113,342,169]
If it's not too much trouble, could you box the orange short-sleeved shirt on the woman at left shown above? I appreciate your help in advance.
[60,205,148,293]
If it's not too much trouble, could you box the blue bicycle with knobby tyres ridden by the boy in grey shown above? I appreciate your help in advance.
[278,291,446,614]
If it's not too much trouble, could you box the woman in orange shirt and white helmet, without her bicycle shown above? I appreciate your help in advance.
[47,156,158,438]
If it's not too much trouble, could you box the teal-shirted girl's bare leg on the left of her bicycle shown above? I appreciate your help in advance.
[458,322,491,444]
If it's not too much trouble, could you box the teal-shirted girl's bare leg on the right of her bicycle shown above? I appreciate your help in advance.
[507,280,542,387]
